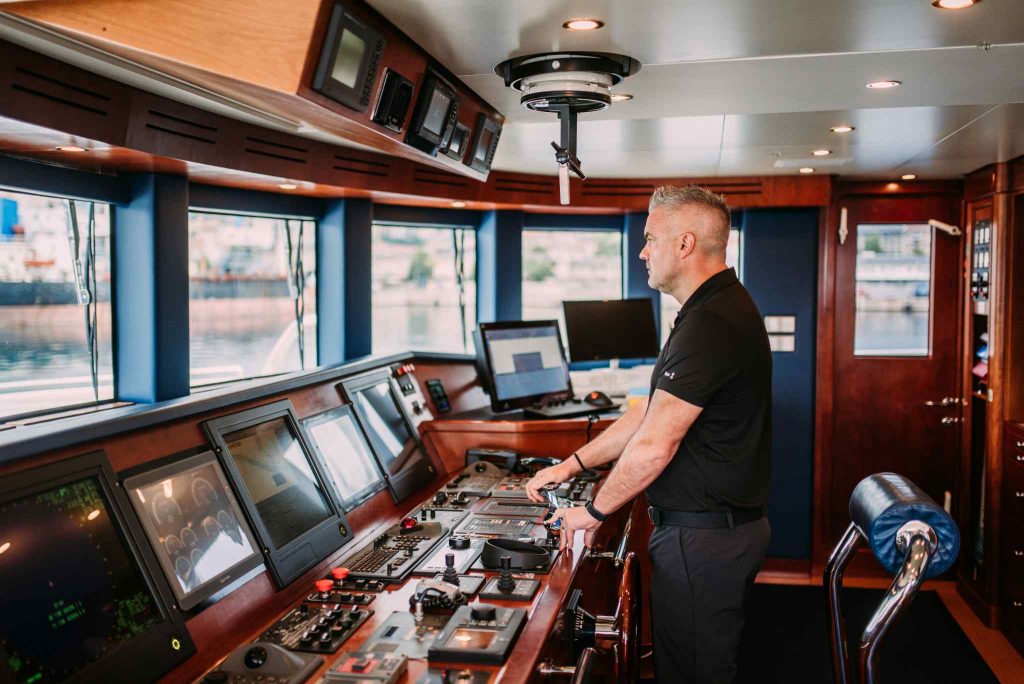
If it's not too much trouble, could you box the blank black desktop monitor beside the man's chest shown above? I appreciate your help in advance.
[562,297,660,361]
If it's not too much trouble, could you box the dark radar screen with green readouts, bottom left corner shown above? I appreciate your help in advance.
[0,477,164,684]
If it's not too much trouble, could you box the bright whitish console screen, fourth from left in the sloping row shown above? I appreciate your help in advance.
[302,404,387,511]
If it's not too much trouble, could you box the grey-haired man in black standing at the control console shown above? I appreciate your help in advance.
[527,185,771,683]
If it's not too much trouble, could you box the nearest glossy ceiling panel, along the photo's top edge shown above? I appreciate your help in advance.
[370,0,1024,76]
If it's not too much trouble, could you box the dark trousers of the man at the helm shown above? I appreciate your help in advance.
[648,518,771,684]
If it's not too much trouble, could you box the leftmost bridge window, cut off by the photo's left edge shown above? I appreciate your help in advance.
[0,190,114,421]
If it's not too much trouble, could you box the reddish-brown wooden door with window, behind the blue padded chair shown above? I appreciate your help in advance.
[822,196,963,548]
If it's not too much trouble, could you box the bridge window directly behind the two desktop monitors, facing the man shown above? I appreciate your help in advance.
[522,230,623,335]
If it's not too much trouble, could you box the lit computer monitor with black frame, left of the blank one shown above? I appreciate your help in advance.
[476,320,572,411]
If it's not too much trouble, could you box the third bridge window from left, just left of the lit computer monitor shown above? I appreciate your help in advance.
[371,223,476,354]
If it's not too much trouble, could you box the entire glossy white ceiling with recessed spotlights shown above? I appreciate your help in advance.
[369,0,1024,178]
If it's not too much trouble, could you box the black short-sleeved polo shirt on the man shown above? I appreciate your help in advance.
[647,268,771,511]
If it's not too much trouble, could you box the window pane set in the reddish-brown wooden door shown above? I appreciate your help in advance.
[853,224,932,356]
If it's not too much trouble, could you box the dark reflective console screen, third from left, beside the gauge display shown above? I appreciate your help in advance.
[224,418,333,549]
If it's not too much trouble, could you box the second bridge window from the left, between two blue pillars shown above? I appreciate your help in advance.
[188,211,316,387]
